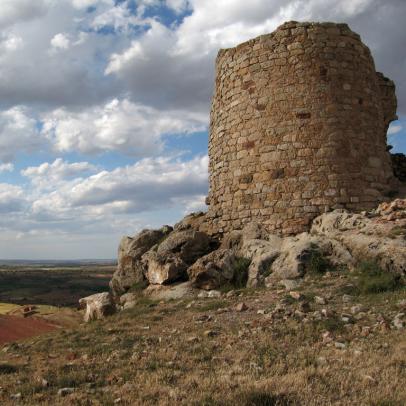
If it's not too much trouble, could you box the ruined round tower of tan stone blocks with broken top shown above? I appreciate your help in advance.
[207,22,396,234]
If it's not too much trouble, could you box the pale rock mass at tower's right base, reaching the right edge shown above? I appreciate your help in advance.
[311,209,406,275]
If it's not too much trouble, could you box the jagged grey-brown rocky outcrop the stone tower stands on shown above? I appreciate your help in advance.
[108,199,406,310]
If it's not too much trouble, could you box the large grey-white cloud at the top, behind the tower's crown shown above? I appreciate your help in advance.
[105,0,406,116]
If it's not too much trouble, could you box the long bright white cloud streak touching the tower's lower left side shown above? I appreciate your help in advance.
[70,156,208,212]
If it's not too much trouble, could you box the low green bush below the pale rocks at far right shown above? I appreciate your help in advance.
[356,261,401,294]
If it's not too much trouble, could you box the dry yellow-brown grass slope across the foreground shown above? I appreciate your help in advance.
[0,273,406,406]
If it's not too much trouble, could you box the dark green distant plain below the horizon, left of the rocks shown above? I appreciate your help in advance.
[0,263,115,306]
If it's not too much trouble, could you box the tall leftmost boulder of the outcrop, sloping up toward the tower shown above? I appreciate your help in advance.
[110,226,172,296]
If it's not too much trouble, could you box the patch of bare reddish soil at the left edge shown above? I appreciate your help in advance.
[0,315,57,344]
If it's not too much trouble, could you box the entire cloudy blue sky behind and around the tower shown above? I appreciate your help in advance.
[0,0,406,259]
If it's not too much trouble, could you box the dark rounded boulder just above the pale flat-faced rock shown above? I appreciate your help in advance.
[156,228,211,265]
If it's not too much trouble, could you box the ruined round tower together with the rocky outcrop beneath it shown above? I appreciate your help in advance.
[83,22,406,318]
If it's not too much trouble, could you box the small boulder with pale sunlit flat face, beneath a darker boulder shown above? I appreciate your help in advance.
[142,250,187,285]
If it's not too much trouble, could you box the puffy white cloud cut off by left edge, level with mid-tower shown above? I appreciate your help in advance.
[0,106,45,162]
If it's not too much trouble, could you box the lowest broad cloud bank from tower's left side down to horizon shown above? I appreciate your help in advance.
[0,156,208,258]
